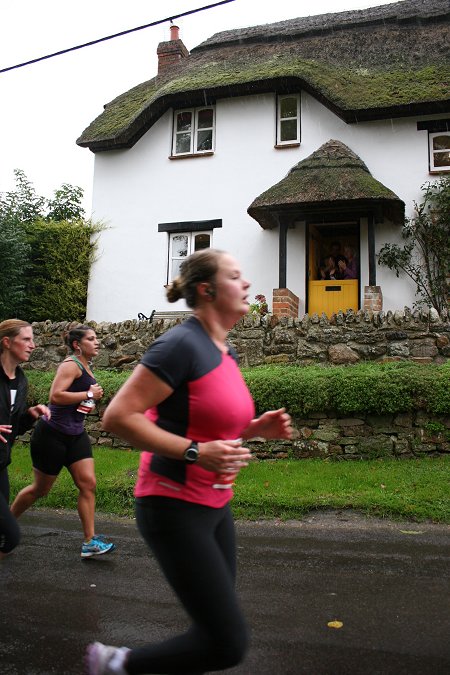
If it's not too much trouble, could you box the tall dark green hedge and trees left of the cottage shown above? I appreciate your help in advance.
[0,169,101,321]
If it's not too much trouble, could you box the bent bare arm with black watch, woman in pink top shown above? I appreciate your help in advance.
[102,364,250,472]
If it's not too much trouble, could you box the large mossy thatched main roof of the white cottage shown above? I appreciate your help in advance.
[77,0,450,152]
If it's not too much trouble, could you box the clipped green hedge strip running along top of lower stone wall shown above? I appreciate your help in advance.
[27,362,450,417]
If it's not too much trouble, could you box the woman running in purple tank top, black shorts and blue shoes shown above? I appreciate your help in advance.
[11,326,115,558]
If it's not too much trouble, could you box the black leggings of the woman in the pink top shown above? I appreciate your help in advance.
[126,497,248,675]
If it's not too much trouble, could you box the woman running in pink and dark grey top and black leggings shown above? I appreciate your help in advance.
[86,249,292,675]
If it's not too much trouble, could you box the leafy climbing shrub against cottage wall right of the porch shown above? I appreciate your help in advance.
[378,176,450,312]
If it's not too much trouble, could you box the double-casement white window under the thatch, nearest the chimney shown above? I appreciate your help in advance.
[172,108,214,155]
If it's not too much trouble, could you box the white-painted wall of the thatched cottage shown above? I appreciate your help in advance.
[87,93,440,322]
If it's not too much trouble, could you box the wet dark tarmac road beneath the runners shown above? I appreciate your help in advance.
[0,510,450,675]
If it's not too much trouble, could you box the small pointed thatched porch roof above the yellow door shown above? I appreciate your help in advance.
[247,140,405,229]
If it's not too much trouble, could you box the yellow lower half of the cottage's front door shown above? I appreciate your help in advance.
[308,279,358,317]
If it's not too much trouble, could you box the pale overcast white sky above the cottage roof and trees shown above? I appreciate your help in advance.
[0,0,400,216]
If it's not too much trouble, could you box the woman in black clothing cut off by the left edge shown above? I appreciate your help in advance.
[0,319,50,560]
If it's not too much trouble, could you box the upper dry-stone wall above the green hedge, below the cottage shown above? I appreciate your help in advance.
[27,307,450,370]
